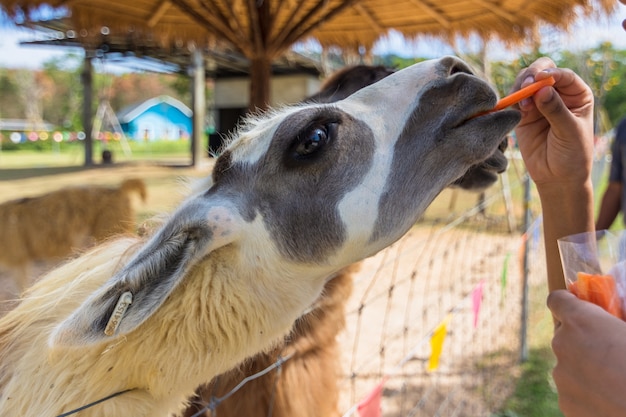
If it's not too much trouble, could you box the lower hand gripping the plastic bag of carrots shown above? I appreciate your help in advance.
[548,290,626,417]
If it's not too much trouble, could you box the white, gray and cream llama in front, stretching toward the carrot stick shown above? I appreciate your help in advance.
[0,57,520,417]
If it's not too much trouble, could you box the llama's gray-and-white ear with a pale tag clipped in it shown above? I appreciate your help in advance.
[50,197,243,346]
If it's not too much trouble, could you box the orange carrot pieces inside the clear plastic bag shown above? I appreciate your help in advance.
[568,272,624,319]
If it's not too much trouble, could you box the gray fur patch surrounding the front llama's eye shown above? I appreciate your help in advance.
[214,106,375,263]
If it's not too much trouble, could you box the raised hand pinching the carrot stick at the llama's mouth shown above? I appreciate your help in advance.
[514,57,594,188]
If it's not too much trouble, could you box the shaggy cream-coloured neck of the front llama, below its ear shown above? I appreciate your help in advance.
[0,239,323,417]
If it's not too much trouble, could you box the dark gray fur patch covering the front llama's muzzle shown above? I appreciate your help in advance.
[372,73,520,240]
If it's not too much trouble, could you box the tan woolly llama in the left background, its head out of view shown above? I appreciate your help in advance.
[0,178,146,290]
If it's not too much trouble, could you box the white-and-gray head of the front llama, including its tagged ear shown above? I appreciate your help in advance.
[51,57,520,345]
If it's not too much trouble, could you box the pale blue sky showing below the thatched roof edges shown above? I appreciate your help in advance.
[0,3,626,68]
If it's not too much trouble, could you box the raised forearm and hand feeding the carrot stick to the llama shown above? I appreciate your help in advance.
[515,58,594,291]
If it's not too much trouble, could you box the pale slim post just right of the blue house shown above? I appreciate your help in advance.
[191,48,209,168]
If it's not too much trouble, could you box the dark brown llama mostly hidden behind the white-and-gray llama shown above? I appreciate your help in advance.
[182,65,507,417]
